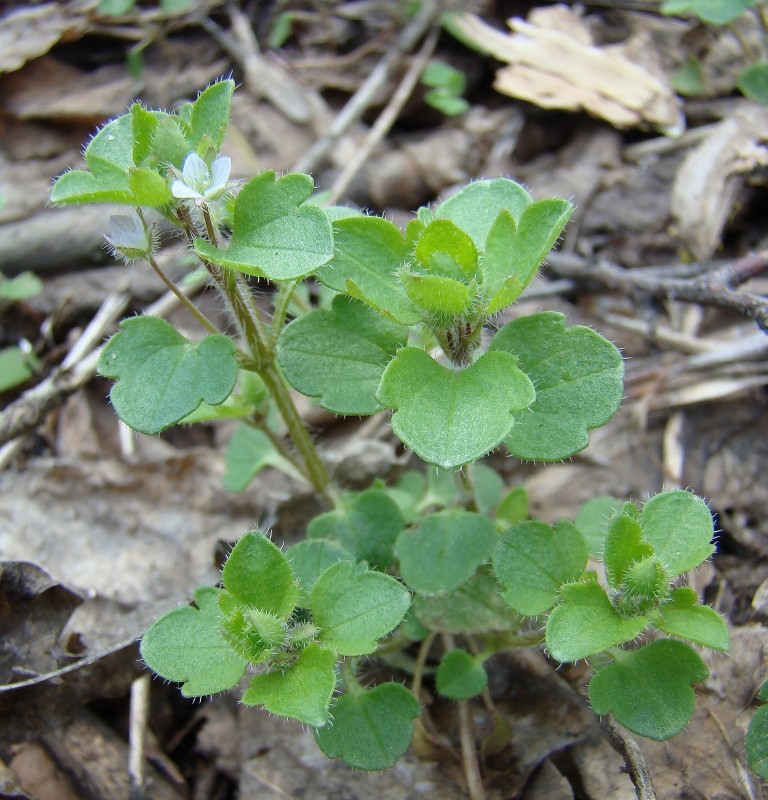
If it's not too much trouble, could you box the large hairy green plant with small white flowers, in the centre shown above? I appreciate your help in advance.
[52,81,728,788]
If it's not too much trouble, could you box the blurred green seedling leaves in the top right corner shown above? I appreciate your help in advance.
[661,0,768,104]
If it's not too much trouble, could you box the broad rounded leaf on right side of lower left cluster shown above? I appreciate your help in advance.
[309,561,411,656]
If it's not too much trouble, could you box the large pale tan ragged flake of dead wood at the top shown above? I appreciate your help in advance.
[452,5,683,131]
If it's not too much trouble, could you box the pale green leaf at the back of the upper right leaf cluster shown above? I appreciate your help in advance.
[432,178,533,251]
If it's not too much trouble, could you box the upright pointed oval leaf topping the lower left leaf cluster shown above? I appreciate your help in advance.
[221,531,299,617]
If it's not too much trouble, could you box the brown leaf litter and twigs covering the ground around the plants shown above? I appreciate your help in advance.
[0,0,768,800]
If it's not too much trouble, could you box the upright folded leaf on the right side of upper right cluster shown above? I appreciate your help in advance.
[482,199,573,314]
